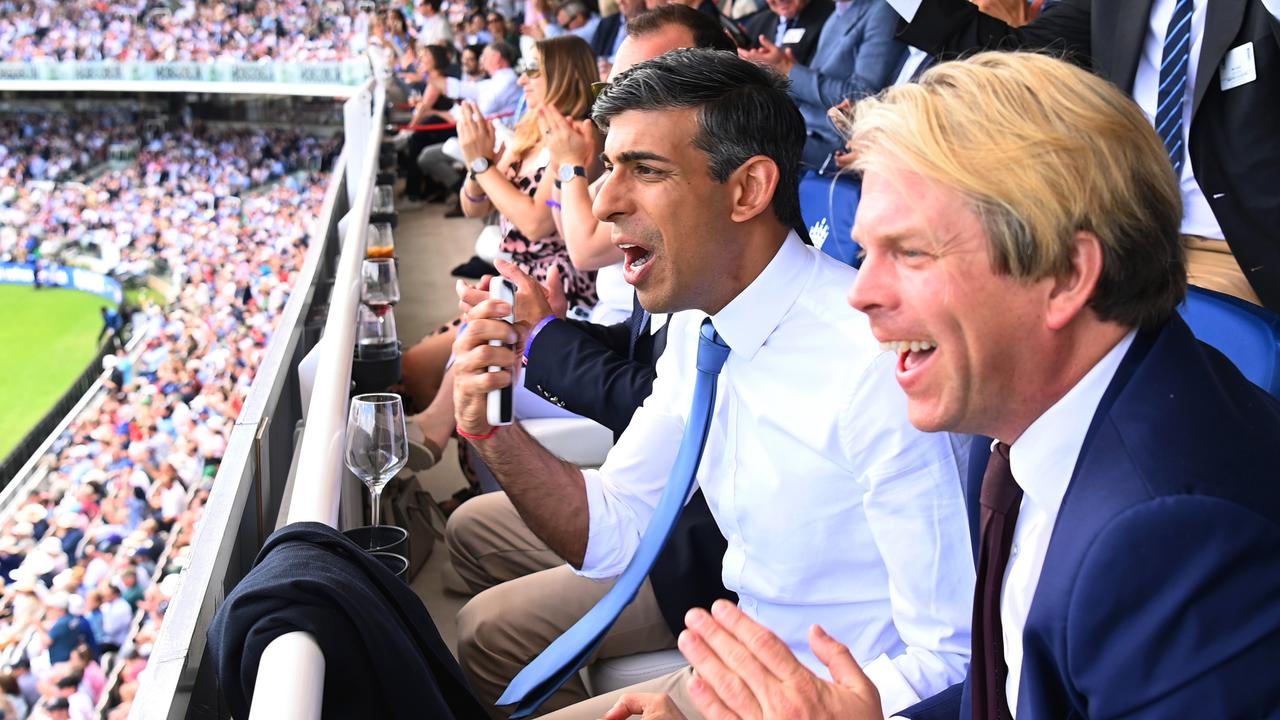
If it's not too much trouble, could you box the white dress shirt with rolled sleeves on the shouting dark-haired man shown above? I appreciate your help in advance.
[581,233,974,711]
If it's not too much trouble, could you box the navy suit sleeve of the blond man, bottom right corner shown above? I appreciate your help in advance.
[1064,496,1280,717]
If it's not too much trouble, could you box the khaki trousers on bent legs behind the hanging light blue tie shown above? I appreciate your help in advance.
[444,492,676,720]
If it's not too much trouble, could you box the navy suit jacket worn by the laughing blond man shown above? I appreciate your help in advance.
[908,316,1280,720]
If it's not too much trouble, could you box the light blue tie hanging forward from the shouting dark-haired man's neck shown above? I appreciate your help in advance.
[497,318,728,720]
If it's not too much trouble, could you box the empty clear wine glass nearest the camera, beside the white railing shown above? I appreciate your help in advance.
[347,393,408,528]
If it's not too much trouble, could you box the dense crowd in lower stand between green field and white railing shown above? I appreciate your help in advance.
[0,114,338,717]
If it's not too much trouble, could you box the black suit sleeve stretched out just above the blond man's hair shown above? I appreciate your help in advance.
[897,0,1091,67]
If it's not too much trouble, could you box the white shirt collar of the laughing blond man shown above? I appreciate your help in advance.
[1009,331,1138,514]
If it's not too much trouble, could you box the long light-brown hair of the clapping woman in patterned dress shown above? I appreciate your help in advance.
[511,35,600,156]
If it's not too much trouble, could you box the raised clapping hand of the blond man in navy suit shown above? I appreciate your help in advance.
[680,600,883,720]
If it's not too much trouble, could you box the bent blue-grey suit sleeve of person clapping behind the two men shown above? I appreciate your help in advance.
[790,3,906,108]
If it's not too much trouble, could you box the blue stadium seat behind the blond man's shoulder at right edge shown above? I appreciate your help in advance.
[1179,286,1280,397]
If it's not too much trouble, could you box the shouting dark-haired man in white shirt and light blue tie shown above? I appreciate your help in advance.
[454,50,973,717]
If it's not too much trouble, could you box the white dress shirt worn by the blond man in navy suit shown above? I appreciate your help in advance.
[1000,331,1135,714]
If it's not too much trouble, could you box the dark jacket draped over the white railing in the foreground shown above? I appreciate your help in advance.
[209,523,486,720]
